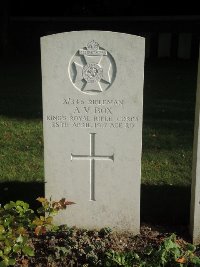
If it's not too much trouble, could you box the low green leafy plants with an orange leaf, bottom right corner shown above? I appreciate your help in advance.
[106,234,200,267]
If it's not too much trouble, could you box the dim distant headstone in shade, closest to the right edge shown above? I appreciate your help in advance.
[178,33,192,59]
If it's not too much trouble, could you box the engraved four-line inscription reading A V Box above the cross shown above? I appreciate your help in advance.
[46,98,139,129]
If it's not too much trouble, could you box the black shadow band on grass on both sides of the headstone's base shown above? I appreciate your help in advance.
[0,182,190,225]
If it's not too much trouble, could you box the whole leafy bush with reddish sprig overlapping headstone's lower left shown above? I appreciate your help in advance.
[0,198,73,267]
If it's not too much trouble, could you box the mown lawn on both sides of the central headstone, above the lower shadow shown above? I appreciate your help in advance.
[0,56,197,186]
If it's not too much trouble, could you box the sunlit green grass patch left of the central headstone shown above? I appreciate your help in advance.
[0,116,44,182]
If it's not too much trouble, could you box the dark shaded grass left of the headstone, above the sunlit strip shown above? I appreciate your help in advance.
[0,57,42,119]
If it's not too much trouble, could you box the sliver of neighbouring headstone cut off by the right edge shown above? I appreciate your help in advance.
[190,48,200,244]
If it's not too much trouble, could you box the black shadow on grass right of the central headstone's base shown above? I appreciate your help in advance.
[141,185,191,225]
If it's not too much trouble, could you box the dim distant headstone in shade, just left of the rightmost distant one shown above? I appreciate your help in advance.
[158,33,172,58]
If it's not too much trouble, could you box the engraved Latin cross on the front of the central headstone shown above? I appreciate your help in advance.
[71,133,114,201]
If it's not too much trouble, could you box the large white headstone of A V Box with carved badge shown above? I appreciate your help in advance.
[41,31,144,234]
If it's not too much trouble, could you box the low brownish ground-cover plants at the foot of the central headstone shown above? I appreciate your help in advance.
[33,225,111,266]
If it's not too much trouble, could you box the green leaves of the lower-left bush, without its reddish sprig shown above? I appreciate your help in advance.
[0,201,34,267]
